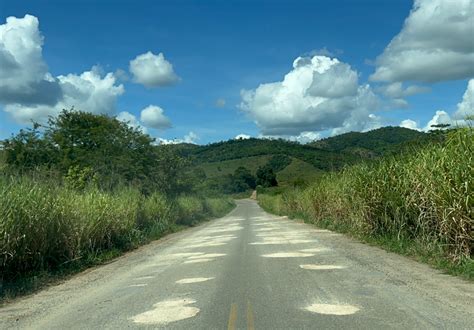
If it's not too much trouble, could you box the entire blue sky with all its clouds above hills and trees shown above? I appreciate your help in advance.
[0,0,474,144]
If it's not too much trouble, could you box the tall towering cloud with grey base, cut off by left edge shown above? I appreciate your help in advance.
[0,15,62,105]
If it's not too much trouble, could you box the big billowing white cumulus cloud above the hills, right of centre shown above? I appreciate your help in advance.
[240,56,379,136]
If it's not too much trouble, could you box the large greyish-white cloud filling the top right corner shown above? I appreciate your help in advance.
[370,0,474,82]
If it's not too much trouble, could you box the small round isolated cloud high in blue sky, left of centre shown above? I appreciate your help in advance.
[129,52,180,87]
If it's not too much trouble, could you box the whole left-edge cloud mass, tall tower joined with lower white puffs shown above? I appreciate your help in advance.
[0,15,124,123]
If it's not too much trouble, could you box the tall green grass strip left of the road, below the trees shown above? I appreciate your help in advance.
[0,177,233,282]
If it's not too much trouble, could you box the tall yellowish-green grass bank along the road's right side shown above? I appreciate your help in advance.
[259,128,474,274]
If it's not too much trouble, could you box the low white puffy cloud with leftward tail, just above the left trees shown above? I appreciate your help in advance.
[4,67,125,123]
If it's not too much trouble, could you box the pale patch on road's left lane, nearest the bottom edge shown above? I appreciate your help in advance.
[129,299,199,325]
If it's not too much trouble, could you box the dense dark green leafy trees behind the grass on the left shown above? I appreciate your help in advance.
[3,110,189,194]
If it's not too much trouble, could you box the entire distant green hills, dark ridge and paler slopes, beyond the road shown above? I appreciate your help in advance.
[167,127,429,188]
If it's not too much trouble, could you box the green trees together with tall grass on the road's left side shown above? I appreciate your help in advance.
[0,110,234,299]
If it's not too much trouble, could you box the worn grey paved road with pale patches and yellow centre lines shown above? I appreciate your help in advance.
[0,200,474,329]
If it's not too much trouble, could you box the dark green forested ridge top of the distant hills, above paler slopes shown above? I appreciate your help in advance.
[175,127,428,170]
